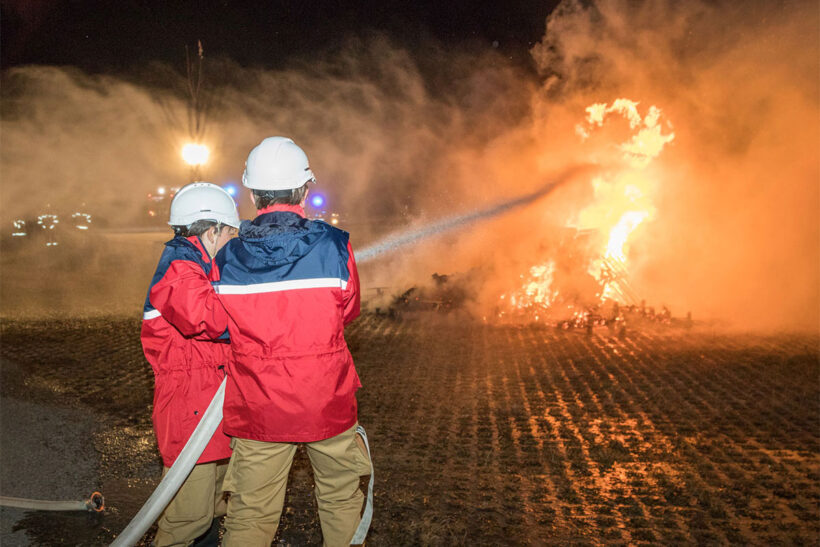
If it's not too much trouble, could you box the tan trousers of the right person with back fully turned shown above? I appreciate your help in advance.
[222,426,370,547]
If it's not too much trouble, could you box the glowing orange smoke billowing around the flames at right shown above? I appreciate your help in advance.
[366,1,820,331]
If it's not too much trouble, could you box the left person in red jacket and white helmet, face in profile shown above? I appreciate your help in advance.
[141,182,239,546]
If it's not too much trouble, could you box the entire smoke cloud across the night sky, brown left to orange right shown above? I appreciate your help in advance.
[0,1,820,329]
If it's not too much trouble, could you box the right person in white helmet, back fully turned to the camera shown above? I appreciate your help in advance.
[215,137,370,547]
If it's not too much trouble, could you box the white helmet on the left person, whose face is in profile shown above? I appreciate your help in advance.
[168,182,239,228]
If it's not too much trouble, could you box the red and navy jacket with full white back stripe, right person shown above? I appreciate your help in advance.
[212,205,361,442]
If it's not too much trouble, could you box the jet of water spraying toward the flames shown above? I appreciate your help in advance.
[356,166,587,263]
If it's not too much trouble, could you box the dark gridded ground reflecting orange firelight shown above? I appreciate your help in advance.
[0,313,820,546]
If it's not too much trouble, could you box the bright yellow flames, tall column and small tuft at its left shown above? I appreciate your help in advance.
[500,98,675,320]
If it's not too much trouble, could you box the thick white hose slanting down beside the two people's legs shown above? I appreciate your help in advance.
[111,377,227,547]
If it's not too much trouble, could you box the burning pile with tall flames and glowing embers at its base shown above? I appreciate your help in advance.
[495,99,675,328]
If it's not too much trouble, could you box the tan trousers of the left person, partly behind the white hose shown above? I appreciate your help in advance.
[154,460,228,547]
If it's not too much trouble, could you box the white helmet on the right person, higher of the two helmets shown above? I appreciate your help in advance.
[242,137,316,190]
